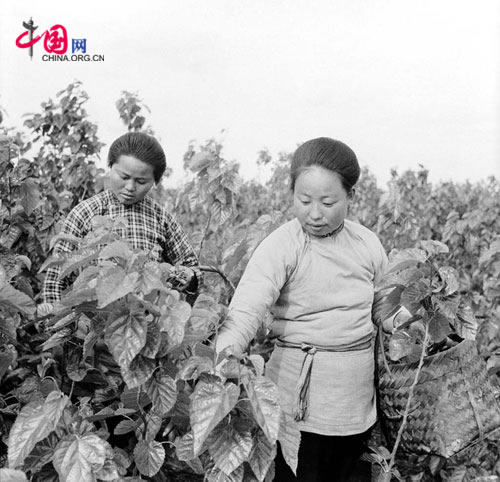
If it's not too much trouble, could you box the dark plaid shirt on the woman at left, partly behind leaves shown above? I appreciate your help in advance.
[42,190,201,303]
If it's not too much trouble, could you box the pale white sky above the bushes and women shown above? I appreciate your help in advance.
[0,0,500,186]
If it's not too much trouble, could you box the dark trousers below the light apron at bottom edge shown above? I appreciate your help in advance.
[274,431,371,482]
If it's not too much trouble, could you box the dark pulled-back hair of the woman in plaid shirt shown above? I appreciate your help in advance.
[108,132,167,184]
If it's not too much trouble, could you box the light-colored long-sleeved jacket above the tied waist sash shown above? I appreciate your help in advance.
[217,219,387,352]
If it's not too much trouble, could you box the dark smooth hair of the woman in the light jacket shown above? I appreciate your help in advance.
[290,137,360,193]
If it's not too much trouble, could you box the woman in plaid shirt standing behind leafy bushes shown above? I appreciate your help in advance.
[39,132,201,308]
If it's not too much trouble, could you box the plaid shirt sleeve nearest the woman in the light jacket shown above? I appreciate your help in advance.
[163,213,203,291]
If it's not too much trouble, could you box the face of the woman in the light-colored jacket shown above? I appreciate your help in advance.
[293,166,352,236]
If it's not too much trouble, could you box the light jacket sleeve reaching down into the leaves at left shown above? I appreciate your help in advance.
[216,228,293,353]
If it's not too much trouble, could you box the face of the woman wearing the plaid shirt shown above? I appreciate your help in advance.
[109,154,155,204]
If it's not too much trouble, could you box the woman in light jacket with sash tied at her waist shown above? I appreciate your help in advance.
[217,137,404,482]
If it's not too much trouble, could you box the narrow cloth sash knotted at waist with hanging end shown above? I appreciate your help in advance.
[276,335,372,422]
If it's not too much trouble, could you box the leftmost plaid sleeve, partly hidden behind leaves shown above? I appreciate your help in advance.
[42,206,88,303]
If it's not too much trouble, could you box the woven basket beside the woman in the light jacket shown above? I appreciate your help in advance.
[377,330,500,458]
